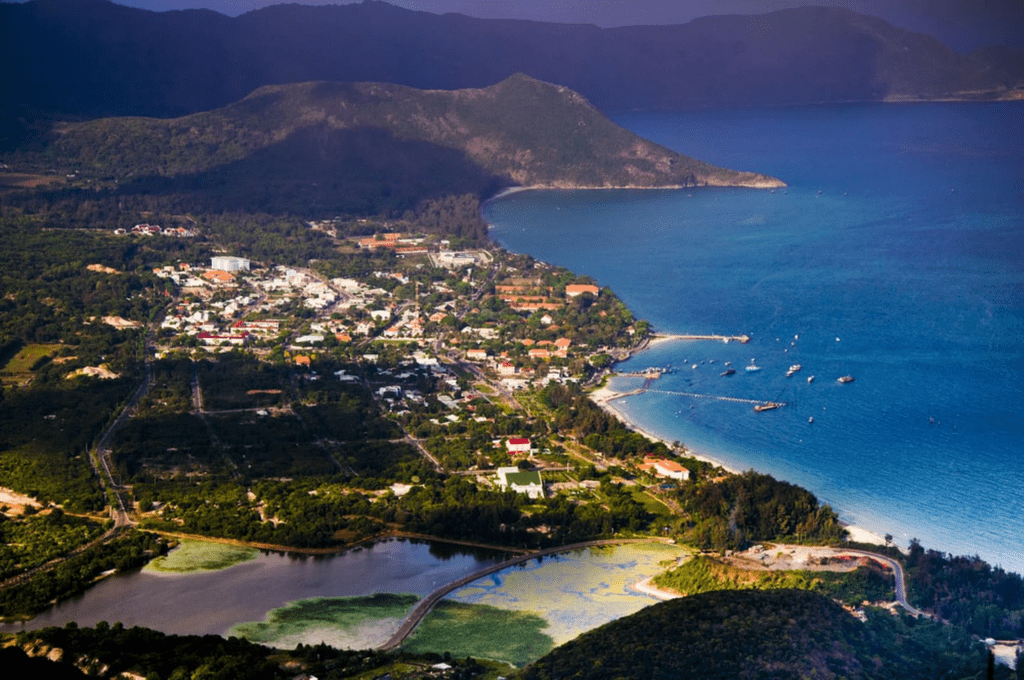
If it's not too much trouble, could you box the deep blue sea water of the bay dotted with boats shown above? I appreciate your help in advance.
[484,103,1024,572]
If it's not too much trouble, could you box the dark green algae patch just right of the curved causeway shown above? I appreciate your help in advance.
[401,600,555,666]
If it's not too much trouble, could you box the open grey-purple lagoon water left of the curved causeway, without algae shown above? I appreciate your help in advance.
[0,541,505,635]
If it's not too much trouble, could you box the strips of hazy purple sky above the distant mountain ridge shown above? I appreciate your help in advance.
[4,0,1024,51]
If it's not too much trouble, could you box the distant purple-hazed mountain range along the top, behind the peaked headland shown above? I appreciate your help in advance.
[0,0,1024,123]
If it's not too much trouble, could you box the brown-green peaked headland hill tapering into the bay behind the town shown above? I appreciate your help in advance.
[12,76,781,214]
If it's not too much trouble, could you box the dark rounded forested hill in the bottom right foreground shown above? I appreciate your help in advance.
[521,590,1011,680]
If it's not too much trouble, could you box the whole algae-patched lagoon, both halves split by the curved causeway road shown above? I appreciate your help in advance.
[6,540,688,665]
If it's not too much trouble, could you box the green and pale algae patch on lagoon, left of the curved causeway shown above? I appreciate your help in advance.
[228,593,420,649]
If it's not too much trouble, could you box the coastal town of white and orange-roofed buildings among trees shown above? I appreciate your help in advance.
[125,221,704,501]
